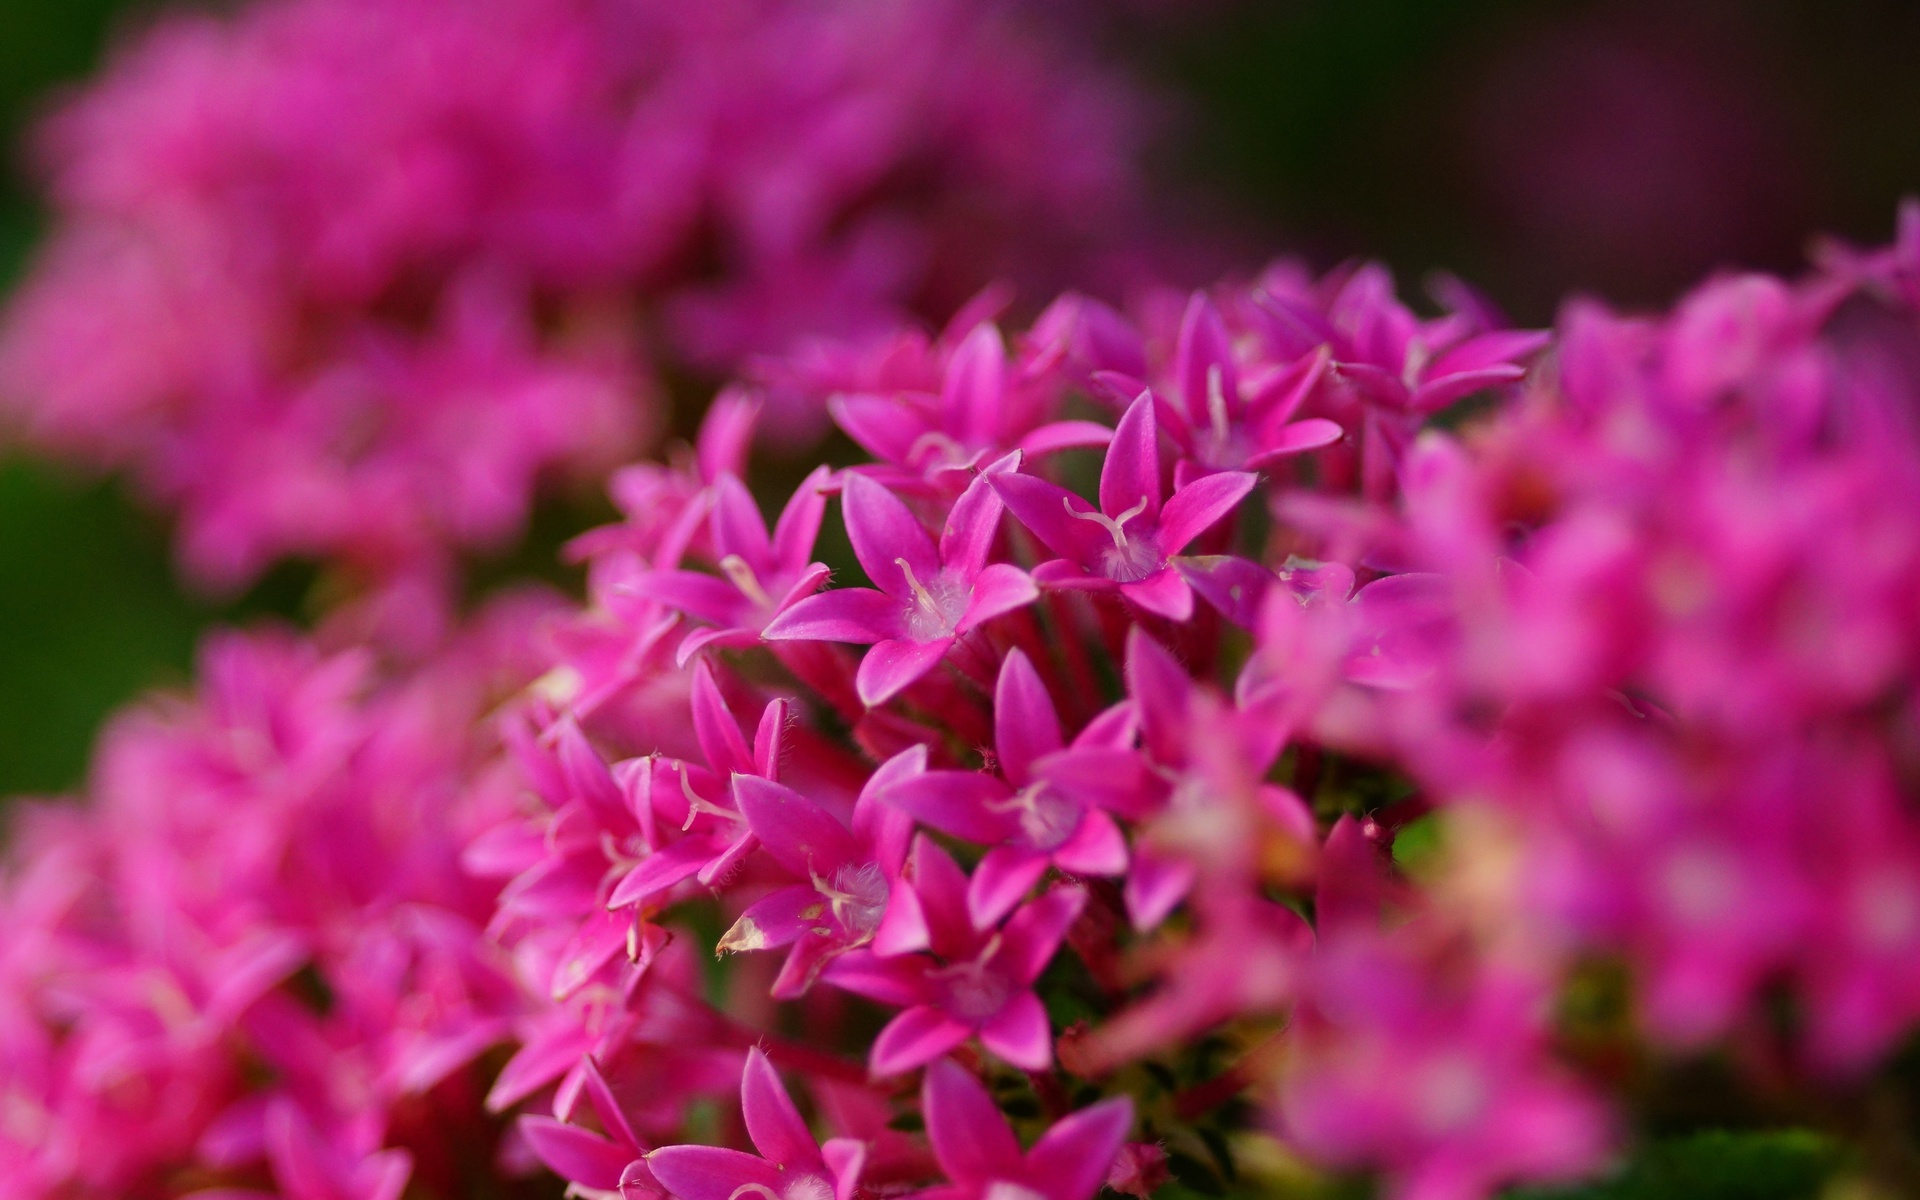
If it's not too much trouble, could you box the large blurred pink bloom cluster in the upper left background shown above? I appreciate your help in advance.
[0,0,1144,625]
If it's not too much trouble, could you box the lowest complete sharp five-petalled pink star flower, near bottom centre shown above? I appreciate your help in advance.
[826,835,1087,1075]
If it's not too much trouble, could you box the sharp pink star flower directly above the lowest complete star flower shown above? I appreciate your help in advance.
[881,647,1131,929]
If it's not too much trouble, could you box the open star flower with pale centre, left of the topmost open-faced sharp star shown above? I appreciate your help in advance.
[762,459,1039,707]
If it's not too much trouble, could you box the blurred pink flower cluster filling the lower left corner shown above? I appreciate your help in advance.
[0,597,553,1200]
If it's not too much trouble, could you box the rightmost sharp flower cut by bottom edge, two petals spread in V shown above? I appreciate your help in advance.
[920,1058,1133,1200]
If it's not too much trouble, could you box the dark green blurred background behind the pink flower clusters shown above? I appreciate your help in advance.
[0,0,1920,795]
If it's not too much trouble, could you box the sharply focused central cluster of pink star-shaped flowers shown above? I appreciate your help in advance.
[468,265,1609,1200]
